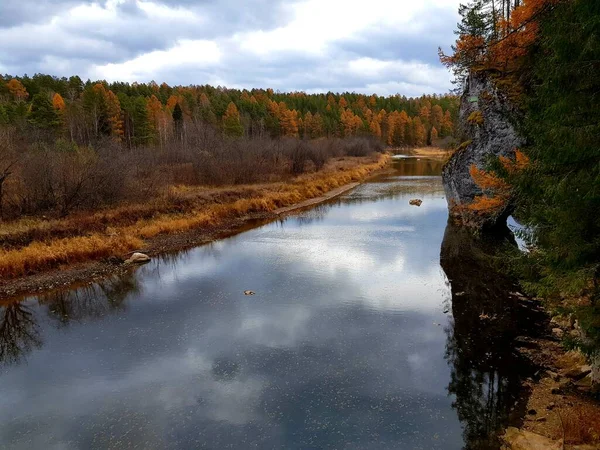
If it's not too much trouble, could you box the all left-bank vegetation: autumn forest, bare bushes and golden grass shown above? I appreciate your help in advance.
[0,74,459,279]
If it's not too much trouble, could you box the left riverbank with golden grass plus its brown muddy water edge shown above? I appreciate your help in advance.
[0,155,390,298]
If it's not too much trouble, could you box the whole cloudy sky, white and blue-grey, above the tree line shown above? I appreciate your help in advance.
[0,0,460,95]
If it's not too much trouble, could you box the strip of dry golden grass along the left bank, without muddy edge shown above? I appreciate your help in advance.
[0,155,389,278]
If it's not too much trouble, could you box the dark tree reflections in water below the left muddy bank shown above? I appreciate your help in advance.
[0,273,140,367]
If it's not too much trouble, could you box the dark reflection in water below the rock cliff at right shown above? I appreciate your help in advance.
[440,224,544,449]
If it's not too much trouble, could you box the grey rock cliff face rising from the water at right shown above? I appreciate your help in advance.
[442,74,523,229]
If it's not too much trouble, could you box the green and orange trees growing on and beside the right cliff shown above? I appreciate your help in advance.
[440,0,600,353]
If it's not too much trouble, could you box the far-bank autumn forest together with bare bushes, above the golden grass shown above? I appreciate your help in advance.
[0,74,458,220]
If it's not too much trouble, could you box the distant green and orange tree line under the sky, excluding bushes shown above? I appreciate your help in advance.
[0,74,458,148]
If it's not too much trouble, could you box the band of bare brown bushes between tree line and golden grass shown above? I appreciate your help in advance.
[0,125,383,217]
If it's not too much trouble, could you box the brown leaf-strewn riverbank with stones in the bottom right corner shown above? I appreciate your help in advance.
[503,308,600,450]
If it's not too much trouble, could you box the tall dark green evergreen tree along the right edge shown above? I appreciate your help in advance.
[510,0,600,298]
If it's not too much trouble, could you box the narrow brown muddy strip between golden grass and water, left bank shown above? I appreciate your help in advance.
[0,156,390,304]
